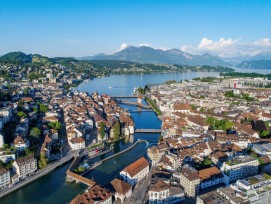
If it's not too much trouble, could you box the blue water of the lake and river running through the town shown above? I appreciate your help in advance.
[0,69,264,204]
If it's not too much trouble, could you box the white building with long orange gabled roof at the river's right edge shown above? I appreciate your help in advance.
[120,157,149,186]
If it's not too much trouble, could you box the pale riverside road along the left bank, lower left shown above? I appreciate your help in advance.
[0,151,79,198]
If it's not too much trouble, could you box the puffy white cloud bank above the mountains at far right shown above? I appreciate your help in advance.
[181,37,271,57]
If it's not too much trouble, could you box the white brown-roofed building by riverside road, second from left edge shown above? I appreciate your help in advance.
[12,154,37,179]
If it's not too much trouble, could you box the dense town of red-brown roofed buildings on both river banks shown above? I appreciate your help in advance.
[0,53,271,204]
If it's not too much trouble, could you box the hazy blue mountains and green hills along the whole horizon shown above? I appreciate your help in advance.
[0,46,271,69]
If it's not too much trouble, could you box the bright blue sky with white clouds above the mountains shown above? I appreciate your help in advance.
[0,0,271,57]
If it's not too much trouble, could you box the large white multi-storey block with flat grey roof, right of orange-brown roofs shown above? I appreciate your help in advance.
[220,156,259,184]
